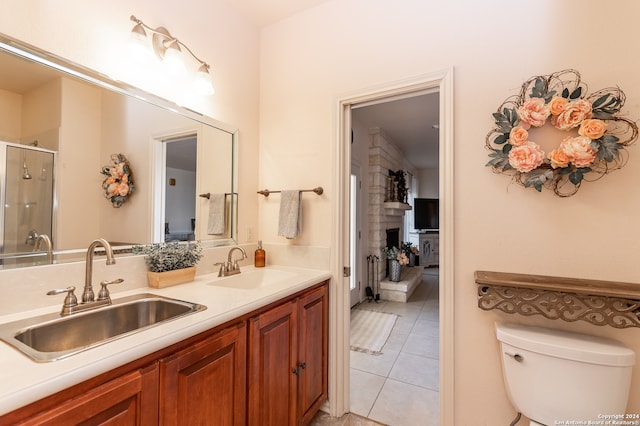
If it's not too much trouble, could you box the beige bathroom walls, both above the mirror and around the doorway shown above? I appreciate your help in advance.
[0,0,640,425]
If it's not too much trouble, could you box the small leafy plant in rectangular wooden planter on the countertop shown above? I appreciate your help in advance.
[132,241,202,288]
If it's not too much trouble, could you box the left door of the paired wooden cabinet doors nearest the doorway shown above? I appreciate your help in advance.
[248,300,299,426]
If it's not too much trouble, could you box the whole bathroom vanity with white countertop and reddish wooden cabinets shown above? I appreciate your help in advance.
[0,267,329,425]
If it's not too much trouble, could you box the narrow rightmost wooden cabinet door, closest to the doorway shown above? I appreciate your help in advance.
[298,285,328,425]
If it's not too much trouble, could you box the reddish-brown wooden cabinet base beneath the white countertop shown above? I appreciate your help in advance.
[0,281,328,426]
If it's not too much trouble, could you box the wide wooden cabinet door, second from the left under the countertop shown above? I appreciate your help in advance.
[160,322,247,426]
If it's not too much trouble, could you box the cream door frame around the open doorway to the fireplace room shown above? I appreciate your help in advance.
[329,67,455,425]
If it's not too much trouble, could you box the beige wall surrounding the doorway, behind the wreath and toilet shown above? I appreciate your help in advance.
[260,0,640,425]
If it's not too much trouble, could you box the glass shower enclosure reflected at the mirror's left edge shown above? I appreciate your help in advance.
[0,142,55,268]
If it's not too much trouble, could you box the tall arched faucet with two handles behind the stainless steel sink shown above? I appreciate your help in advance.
[47,238,124,316]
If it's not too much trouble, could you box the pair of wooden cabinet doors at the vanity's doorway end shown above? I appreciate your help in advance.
[248,286,328,426]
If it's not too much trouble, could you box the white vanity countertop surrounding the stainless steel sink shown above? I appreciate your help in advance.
[0,266,331,414]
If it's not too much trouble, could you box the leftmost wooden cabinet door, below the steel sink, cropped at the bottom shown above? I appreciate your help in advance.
[10,363,158,426]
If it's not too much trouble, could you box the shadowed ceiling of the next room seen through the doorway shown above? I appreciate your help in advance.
[351,92,440,169]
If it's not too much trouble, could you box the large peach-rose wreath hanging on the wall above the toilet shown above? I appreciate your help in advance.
[486,69,638,197]
